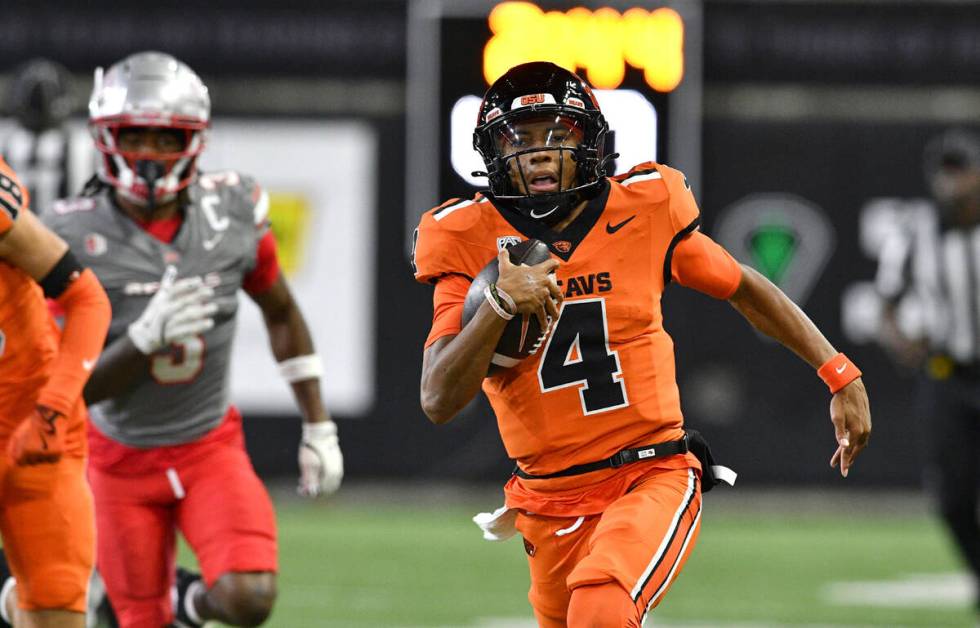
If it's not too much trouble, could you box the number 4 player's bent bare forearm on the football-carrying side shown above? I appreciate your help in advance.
[421,303,507,425]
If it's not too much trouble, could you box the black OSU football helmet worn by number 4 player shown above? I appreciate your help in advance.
[473,61,615,226]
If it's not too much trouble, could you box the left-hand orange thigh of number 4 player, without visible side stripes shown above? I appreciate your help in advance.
[515,512,599,627]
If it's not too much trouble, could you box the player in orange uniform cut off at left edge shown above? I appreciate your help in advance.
[0,160,110,628]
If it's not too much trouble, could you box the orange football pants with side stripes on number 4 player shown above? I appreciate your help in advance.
[516,469,701,628]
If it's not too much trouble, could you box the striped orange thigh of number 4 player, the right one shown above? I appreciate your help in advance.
[568,469,701,616]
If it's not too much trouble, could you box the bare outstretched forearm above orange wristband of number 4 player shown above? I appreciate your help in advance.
[729,264,837,368]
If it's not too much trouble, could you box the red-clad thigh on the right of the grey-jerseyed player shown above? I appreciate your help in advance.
[177,443,278,586]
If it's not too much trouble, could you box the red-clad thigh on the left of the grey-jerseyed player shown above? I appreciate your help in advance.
[88,467,176,626]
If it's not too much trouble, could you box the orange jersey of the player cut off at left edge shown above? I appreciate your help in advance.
[0,160,59,438]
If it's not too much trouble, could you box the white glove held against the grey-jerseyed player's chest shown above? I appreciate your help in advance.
[128,266,218,355]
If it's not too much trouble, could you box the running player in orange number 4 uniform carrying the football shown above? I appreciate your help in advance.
[415,62,871,628]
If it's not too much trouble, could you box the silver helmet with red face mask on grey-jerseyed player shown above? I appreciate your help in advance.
[89,52,211,209]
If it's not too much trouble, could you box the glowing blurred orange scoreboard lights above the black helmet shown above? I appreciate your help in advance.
[483,2,684,92]
